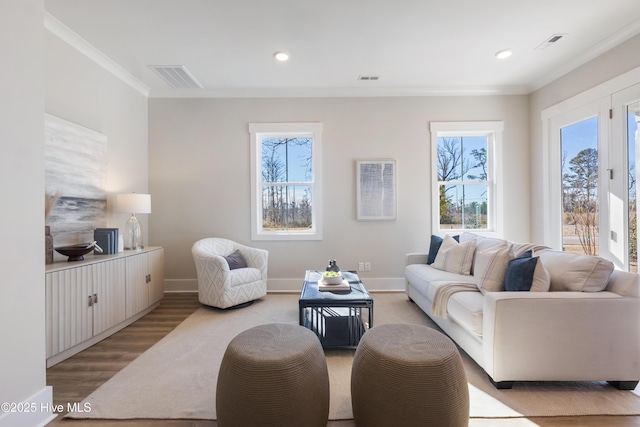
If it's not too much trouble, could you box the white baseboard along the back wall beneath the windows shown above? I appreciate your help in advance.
[164,277,405,293]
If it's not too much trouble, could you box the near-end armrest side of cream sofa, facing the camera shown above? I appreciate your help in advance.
[483,291,640,382]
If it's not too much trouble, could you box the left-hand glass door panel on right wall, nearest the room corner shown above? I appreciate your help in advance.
[545,97,608,259]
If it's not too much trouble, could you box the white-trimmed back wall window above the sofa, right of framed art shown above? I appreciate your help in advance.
[430,121,503,235]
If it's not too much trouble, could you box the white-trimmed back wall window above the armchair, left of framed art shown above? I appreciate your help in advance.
[249,123,322,240]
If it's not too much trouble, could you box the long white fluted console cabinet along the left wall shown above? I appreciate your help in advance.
[45,247,164,367]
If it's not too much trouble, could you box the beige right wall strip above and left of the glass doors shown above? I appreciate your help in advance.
[529,35,640,243]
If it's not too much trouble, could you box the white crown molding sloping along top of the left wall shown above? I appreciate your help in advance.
[44,11,150,97]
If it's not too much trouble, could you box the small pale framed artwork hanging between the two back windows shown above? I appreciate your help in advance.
[356,159,396,221]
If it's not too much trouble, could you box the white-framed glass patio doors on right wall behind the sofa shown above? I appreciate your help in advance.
[542,82,640,272]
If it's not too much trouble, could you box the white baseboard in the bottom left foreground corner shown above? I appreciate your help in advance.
[0,386,56,427]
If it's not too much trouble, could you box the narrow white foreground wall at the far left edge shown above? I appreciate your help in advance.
[0,0,52,427]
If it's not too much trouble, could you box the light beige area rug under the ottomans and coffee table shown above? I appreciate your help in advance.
[67,293,640,420]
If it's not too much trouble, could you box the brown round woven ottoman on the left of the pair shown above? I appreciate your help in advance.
[216,324,329,427]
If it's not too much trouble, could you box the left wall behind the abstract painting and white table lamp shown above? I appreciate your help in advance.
[44,26,154,251]
